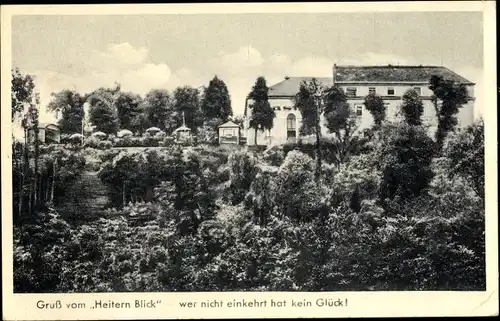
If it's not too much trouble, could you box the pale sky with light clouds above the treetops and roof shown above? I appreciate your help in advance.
[12,12,483,121]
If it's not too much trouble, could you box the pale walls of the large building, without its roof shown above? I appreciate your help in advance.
[243,84,474,146]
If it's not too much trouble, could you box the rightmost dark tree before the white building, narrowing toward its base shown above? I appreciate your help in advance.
[429,76,468,151]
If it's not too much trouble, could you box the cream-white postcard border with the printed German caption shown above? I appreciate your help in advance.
[1,1,498,320]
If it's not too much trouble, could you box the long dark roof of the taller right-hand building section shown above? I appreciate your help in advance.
[334,65,472,84]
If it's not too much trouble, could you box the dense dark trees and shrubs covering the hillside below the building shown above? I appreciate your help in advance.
[12,68,485,292]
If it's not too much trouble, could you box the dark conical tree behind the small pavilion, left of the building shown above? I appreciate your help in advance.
[201,76,233,122]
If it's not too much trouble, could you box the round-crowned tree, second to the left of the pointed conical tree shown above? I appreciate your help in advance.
[143,89,177,133]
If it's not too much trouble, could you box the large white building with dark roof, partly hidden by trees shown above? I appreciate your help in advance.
[244,65,474,145]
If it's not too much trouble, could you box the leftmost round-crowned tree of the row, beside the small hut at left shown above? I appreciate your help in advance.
[47,89,84,134]
